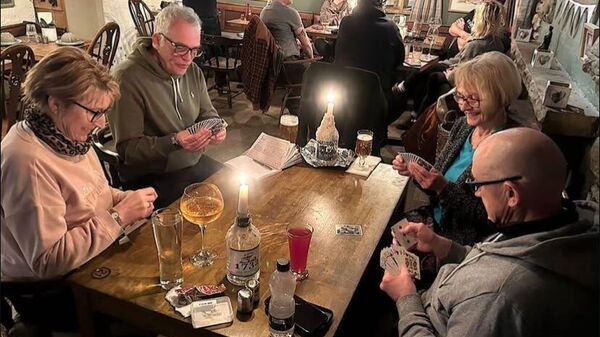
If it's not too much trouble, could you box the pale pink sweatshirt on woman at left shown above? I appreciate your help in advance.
[0,122,127,281]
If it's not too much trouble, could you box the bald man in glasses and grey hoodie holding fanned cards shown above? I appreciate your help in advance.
[380,128,599,337]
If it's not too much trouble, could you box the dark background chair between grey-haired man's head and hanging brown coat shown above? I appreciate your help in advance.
[199,34,242,109]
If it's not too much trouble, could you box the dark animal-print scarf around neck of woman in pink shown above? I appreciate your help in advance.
[25,107,92,157]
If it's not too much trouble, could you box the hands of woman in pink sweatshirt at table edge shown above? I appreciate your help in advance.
[113,187,158,225]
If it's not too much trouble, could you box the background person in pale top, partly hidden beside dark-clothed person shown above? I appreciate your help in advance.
[314,0,352,62]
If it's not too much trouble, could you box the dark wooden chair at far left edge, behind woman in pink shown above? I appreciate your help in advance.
[0,44,35,139]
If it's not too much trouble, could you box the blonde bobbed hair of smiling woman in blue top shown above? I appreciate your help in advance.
[454,51,522,120]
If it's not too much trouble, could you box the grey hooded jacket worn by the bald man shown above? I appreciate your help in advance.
[396,205,600,337]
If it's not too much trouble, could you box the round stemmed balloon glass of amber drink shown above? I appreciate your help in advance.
[179,183,224,267]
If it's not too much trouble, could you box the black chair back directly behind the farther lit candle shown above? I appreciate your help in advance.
[297,62,387,155]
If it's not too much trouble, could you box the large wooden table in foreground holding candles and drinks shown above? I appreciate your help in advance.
[69,164,407,337]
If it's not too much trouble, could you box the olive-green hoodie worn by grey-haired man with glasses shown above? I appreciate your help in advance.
[108,38,218,181]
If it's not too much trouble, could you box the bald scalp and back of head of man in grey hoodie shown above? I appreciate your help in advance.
[473,128,567,215]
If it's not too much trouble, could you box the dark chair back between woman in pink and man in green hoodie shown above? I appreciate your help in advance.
[92,126,123,188]
